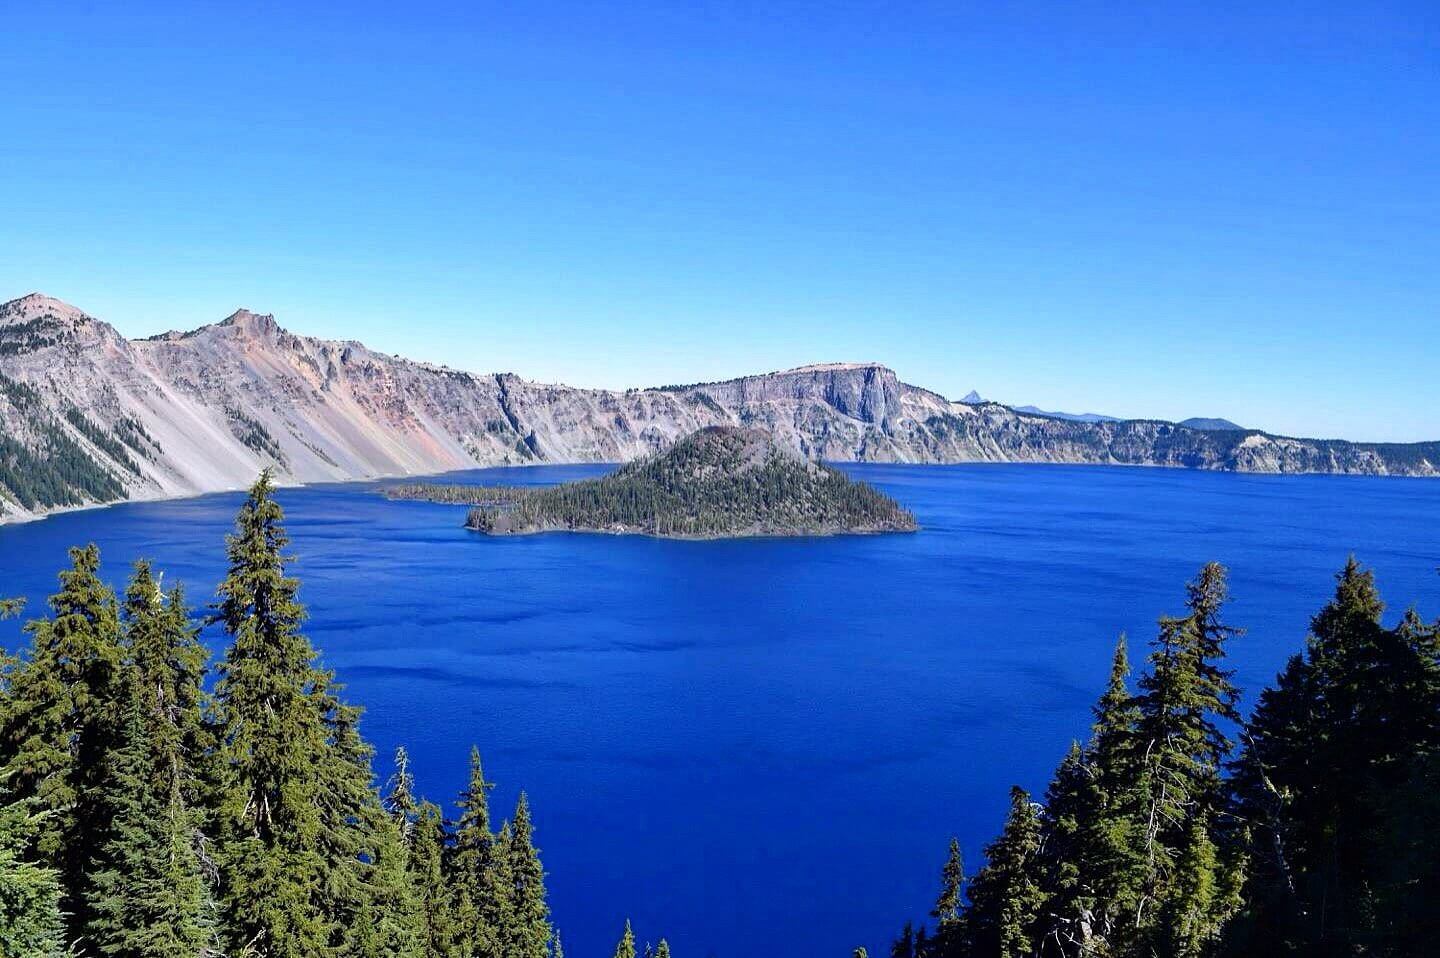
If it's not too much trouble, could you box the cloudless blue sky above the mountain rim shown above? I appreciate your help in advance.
[0,0,1440,439]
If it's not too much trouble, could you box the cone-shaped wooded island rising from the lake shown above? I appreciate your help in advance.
[387,426,914,537]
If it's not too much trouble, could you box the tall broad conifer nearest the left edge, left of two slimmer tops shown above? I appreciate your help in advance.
[0,545,121,941]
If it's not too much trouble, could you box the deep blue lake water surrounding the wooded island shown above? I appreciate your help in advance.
[0,465,1440,958]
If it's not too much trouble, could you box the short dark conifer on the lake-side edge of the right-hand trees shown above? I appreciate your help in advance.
[965,785,1041,958]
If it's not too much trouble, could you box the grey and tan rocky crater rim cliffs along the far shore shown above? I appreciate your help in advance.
[0,294,1440,519]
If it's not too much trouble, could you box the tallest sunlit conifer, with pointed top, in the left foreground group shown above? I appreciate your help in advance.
[215,473,366,958]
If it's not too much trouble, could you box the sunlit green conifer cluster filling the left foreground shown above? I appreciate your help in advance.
[0,474,670,958]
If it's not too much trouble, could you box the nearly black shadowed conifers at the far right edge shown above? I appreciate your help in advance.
[1234,559,1440,954]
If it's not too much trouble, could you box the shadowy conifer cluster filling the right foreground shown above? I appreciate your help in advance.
[875,559,1440,958]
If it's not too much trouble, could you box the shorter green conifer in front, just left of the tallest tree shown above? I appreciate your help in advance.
[86,670,220,958]
